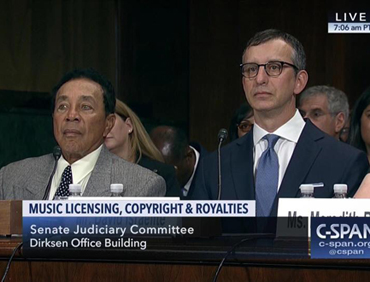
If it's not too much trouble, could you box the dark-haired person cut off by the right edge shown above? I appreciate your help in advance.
[348,87,370,162]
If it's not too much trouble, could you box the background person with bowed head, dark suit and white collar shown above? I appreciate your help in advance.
[150,125,208,199]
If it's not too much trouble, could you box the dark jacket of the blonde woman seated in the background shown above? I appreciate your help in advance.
[138,156,181,197]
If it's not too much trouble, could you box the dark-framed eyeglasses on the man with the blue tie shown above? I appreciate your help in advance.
[240,61,298,78]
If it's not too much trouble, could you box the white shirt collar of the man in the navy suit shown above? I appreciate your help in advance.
[253,109,305,146]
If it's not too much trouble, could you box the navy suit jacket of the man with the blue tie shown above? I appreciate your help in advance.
[192,120,369,215]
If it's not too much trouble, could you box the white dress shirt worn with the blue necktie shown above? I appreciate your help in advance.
[253,110,305,190]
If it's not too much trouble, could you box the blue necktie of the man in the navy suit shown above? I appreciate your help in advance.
[256,134,280,216]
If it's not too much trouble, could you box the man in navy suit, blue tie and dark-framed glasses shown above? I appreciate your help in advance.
[193,29,368,217]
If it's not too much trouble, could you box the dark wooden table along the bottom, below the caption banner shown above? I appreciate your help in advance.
[0,238,370,282]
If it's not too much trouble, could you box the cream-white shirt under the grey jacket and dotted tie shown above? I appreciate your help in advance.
[49,145,103,200]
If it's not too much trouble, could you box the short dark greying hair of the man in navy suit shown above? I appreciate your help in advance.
[243,29,306,70]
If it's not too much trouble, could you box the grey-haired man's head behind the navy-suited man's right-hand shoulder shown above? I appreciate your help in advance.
[298,85,349,140]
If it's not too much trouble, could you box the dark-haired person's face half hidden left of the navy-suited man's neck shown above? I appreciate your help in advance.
[229,102,254,142]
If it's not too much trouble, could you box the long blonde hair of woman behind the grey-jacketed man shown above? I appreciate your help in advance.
[116,99,164,163]
